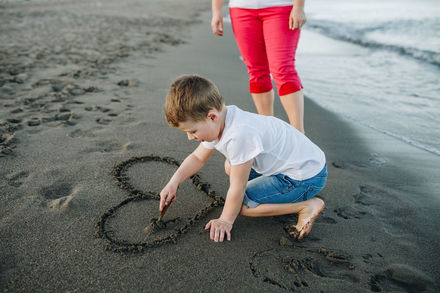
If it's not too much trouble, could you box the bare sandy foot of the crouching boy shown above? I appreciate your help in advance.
[289,197,325,239]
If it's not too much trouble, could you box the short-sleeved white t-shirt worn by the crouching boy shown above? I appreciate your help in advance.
[202,106,325,180]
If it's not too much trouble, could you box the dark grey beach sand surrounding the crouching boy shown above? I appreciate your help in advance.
[0,1,440,292]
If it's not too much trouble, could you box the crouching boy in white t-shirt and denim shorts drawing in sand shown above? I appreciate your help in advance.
[159,75,327,242]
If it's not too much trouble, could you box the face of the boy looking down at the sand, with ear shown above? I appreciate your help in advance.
[177,111,221,142]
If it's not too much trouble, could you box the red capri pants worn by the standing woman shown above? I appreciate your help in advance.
[229,6,303,96]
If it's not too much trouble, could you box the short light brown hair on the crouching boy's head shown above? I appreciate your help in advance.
[164,75,224,127]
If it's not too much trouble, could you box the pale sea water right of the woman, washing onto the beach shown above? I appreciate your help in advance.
[296,0,440,156]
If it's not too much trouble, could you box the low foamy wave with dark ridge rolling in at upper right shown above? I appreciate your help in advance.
[307,19,440,67]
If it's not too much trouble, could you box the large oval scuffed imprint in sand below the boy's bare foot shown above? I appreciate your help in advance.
[250,246,361,291]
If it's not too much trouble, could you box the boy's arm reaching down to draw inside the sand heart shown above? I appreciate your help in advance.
[159,144,215,211]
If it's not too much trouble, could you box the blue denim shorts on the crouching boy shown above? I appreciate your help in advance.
[243,164,328,208]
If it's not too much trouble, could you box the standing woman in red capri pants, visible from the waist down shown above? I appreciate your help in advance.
[211,0,306,133]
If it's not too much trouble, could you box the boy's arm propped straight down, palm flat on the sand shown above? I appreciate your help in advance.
[205,159,254,242]
